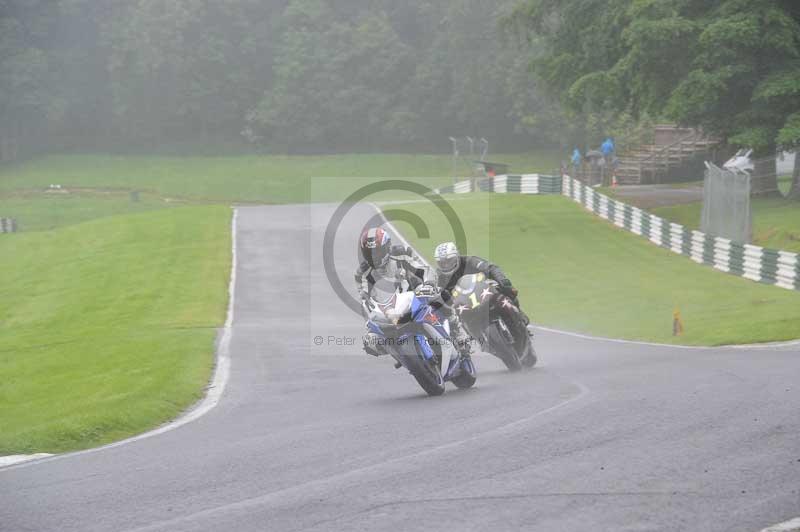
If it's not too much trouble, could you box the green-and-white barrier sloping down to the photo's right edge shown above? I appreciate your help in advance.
[562,176,800,290]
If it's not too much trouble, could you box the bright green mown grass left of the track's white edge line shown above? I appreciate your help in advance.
[0,206,231,455]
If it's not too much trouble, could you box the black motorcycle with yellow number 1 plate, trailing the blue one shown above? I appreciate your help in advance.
[451,273,537,371]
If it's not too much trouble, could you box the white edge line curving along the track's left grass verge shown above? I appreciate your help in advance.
[0,207,239,472]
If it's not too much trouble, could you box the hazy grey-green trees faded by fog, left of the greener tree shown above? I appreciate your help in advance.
[0,0,554,158]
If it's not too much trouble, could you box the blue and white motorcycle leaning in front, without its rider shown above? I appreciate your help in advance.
[363,283,476,395]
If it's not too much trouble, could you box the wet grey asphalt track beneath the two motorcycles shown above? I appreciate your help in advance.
[0,202,800,532]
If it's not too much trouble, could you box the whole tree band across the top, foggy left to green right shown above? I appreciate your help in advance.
[0,0,800,166]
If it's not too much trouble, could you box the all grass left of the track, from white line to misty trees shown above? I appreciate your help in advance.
[0,154,564,455]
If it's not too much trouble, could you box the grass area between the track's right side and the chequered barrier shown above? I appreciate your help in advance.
[398,194,800,345]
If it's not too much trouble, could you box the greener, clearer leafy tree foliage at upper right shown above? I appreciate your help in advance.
[511,0,800,153]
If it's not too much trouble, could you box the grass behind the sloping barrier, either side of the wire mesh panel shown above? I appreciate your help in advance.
[652,198,800,253]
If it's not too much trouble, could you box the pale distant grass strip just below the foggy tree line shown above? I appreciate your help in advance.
[0,150,558,203]
